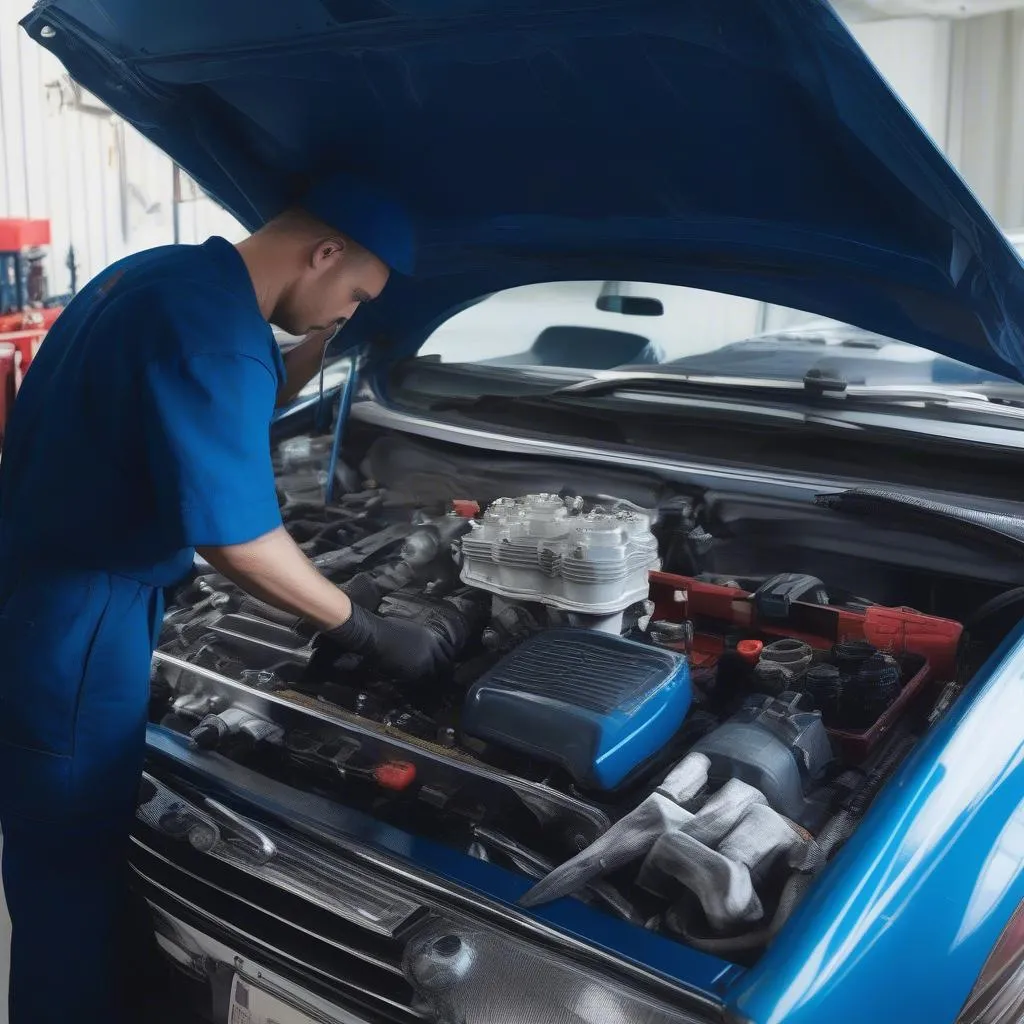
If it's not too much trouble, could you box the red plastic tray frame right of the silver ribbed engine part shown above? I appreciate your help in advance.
[650,572,964,758]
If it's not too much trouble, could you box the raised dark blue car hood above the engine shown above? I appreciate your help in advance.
[24,0,1024,379]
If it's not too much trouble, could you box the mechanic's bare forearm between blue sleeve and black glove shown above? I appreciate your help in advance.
[197,526,352,630]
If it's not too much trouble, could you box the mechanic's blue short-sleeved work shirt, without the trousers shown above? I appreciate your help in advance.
[0,238,284,587]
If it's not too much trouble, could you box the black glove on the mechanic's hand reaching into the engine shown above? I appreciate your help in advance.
[321,601,453,680]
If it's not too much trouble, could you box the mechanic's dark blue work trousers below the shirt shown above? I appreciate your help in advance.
[0,565,162,1024]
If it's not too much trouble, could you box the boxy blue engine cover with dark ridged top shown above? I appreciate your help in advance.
[462,629,690,790]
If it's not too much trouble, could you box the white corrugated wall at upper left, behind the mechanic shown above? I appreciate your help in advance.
[0,0,244,294]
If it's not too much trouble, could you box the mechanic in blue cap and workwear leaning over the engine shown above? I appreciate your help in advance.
[0,175,450,1024]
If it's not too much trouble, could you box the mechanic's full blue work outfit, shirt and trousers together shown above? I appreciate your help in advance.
[0,238,284,1024]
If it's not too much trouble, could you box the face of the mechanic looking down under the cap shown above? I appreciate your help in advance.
[272,238,390,335]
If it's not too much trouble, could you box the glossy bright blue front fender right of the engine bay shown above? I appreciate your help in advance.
[729,626,1024,1024]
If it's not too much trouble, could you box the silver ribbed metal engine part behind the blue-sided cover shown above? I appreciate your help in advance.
[462,495,660,615]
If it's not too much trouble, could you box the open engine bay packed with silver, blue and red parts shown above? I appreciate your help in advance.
[151,430,991,963]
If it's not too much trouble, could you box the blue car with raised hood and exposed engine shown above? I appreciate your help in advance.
[18,0,1024,1024]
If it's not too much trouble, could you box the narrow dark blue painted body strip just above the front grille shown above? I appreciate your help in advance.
[146,725,741,998]
